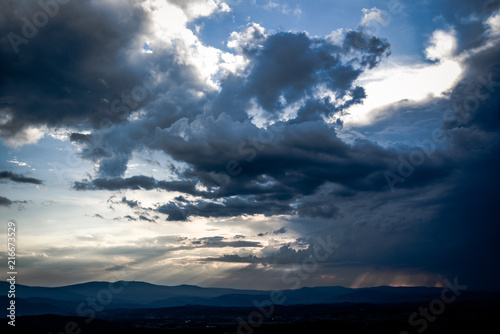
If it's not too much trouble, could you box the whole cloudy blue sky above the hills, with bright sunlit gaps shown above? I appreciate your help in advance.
[0,0,500,290]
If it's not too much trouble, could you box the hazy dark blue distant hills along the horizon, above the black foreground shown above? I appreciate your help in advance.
[0,281,500,316]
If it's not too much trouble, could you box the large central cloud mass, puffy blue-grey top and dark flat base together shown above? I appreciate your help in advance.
[67,24,406,220]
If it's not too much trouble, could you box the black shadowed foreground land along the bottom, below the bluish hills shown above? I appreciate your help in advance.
[1,301,500,334]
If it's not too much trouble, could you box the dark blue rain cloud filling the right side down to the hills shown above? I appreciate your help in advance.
[326,10,500,290]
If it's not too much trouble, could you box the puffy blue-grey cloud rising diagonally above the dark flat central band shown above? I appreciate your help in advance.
[59,24,389,183]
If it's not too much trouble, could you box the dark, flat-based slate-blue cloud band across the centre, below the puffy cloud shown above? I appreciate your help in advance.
[166,119,458,200]
